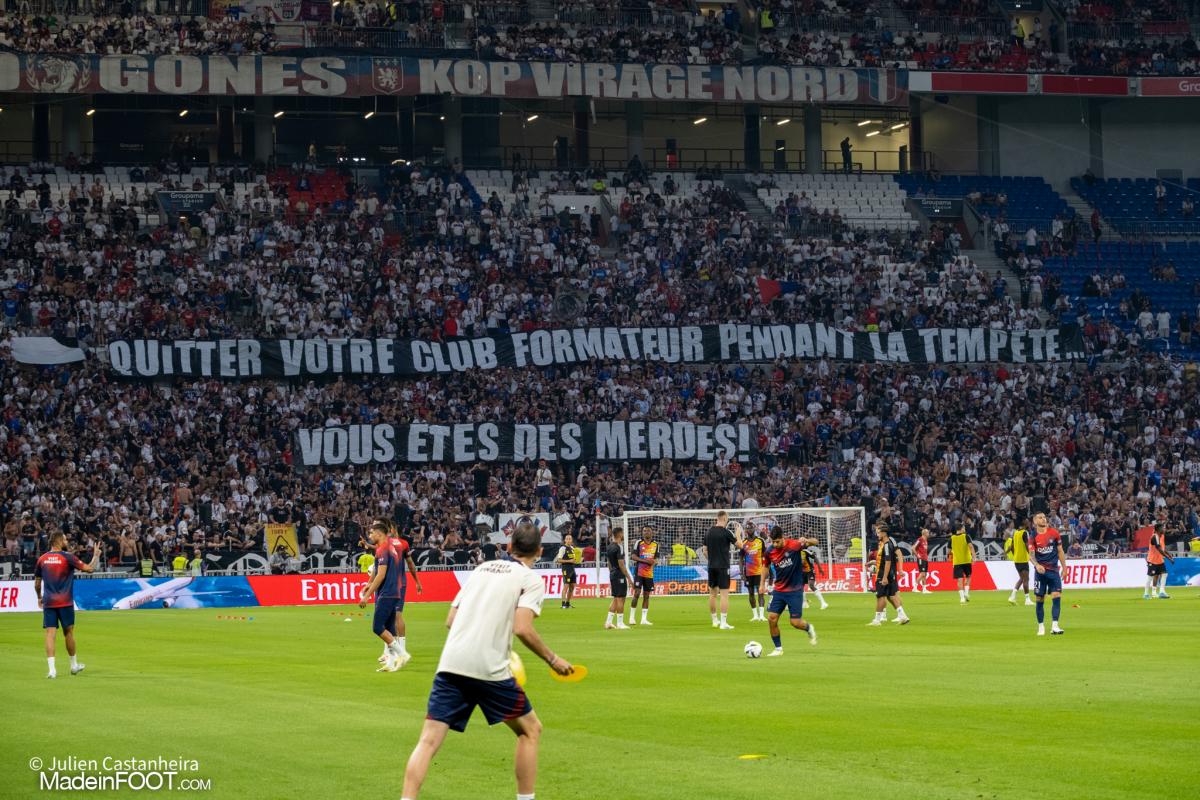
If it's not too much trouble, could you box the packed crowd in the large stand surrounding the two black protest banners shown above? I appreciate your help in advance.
[0,149,1200,575]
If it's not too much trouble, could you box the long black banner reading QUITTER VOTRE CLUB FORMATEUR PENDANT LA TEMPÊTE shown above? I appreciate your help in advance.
[108,324,1085,380]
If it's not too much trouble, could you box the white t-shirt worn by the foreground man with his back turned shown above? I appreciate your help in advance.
[438,561,546,680]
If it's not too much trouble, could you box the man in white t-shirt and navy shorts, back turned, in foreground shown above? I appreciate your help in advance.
[402,523,574,800]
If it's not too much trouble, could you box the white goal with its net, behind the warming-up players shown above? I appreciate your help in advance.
[613,506,868,595]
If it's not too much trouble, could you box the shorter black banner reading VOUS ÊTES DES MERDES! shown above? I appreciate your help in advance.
[294,421,755,468]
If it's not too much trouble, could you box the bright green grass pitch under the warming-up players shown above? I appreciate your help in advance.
[0,589,1200,800]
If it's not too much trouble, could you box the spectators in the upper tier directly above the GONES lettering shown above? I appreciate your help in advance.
[0,12,276,55]
